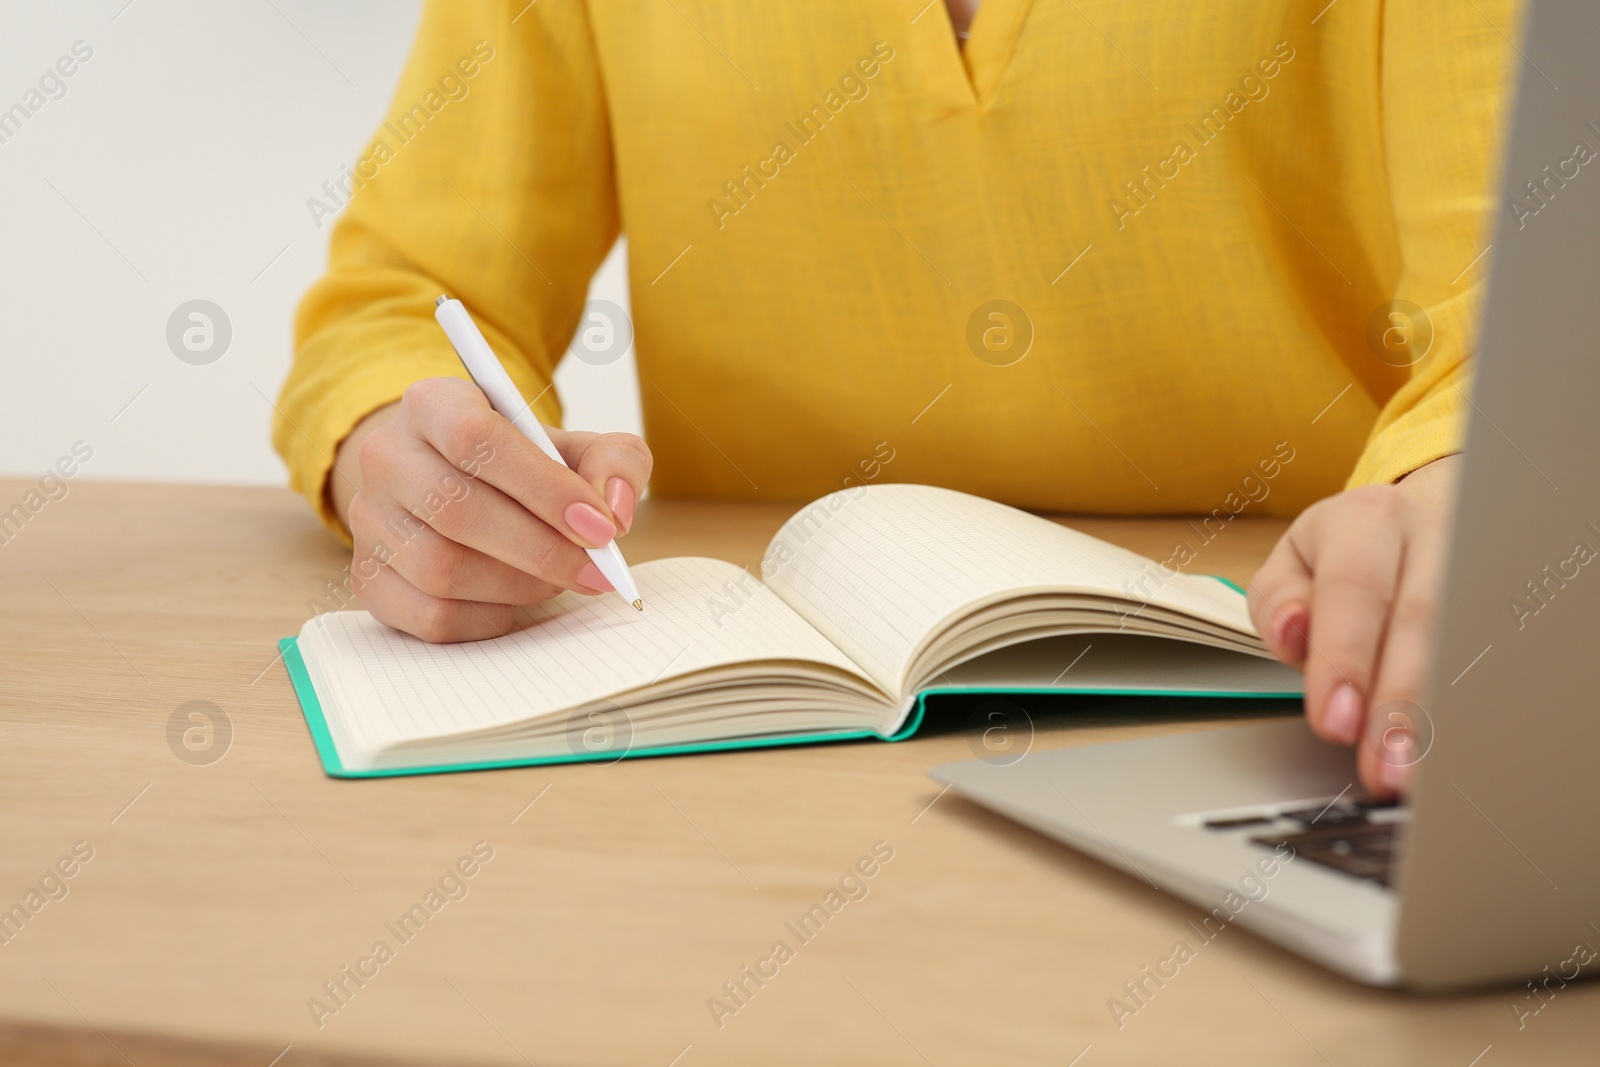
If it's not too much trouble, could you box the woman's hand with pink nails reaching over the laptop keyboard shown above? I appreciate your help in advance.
[1250,456,1461,795]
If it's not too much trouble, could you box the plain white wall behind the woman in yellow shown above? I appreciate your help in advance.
[0,0,640,483]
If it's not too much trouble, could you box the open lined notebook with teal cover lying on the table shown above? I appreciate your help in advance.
[282,485,1301,777]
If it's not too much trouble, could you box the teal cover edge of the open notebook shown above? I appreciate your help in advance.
[278,604,1301,777]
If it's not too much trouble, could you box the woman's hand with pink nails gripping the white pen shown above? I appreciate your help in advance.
[328,378,651,641]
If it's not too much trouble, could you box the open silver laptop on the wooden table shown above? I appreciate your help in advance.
[933,0,1600,990]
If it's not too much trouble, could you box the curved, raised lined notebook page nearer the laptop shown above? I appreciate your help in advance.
[765,485,1254,691]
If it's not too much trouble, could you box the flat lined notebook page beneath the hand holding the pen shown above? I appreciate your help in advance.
[301,558,861,745]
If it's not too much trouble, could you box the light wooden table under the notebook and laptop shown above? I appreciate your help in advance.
[0,482,1600,1067]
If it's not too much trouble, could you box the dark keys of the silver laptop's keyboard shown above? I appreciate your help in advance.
[1202,797,1408,888]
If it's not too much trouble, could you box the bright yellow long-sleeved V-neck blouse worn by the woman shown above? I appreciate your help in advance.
[274,0,1517,526]
